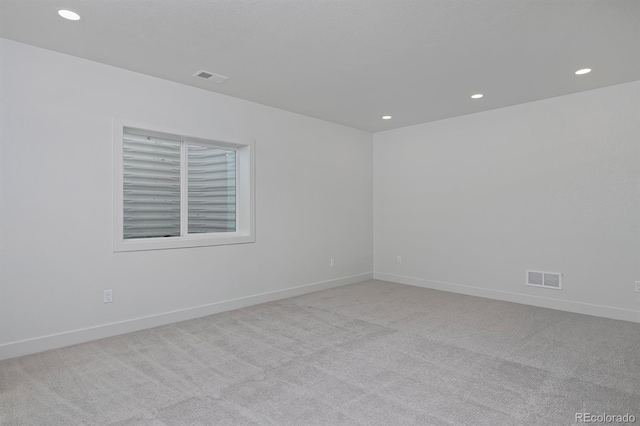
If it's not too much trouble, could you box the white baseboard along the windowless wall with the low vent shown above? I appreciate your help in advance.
[373,272,640,323]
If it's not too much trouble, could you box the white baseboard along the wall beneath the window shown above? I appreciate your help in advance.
[0,273,373,360]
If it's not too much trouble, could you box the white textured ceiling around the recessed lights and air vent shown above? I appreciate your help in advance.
[0,0,640,131]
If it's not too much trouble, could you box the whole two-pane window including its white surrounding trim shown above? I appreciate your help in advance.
[114,124,255,251]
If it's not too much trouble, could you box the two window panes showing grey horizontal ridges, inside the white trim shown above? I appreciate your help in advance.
[123,131,236,240]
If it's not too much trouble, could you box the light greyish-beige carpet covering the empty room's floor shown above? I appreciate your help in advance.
[0,281,640,426]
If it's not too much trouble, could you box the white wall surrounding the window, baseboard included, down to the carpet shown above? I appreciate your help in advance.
[0,39,373,358]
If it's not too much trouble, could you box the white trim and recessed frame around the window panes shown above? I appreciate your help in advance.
[112,117,255,252]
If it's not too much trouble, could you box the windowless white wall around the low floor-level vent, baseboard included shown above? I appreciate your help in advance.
[374,82,640,322]
